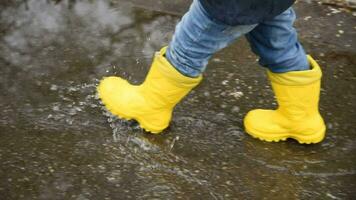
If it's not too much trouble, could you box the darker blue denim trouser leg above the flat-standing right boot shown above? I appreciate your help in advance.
[246,8,309,73]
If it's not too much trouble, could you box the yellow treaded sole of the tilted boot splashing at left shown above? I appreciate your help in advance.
[97,86,167,134]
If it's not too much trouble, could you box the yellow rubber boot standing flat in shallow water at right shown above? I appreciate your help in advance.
[244,56,325,144]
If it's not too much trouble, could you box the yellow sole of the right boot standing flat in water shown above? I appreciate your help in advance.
[245,121,325,144]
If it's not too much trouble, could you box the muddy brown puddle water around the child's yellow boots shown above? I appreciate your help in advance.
[0,0,356,199]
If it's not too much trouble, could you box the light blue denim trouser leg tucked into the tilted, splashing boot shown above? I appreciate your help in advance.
[166,0,256,77]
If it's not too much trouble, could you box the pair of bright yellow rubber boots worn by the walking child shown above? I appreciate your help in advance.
[97,48,325,144]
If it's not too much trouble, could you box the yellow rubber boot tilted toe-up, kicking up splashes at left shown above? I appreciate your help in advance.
[97,47,202,134]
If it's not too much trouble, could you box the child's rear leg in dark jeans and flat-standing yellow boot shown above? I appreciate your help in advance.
[244,9,325,144]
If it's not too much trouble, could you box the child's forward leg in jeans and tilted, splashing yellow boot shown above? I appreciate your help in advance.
[97,0,255,133]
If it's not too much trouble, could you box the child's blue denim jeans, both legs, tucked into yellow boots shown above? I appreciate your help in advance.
[166,0,309,77]
